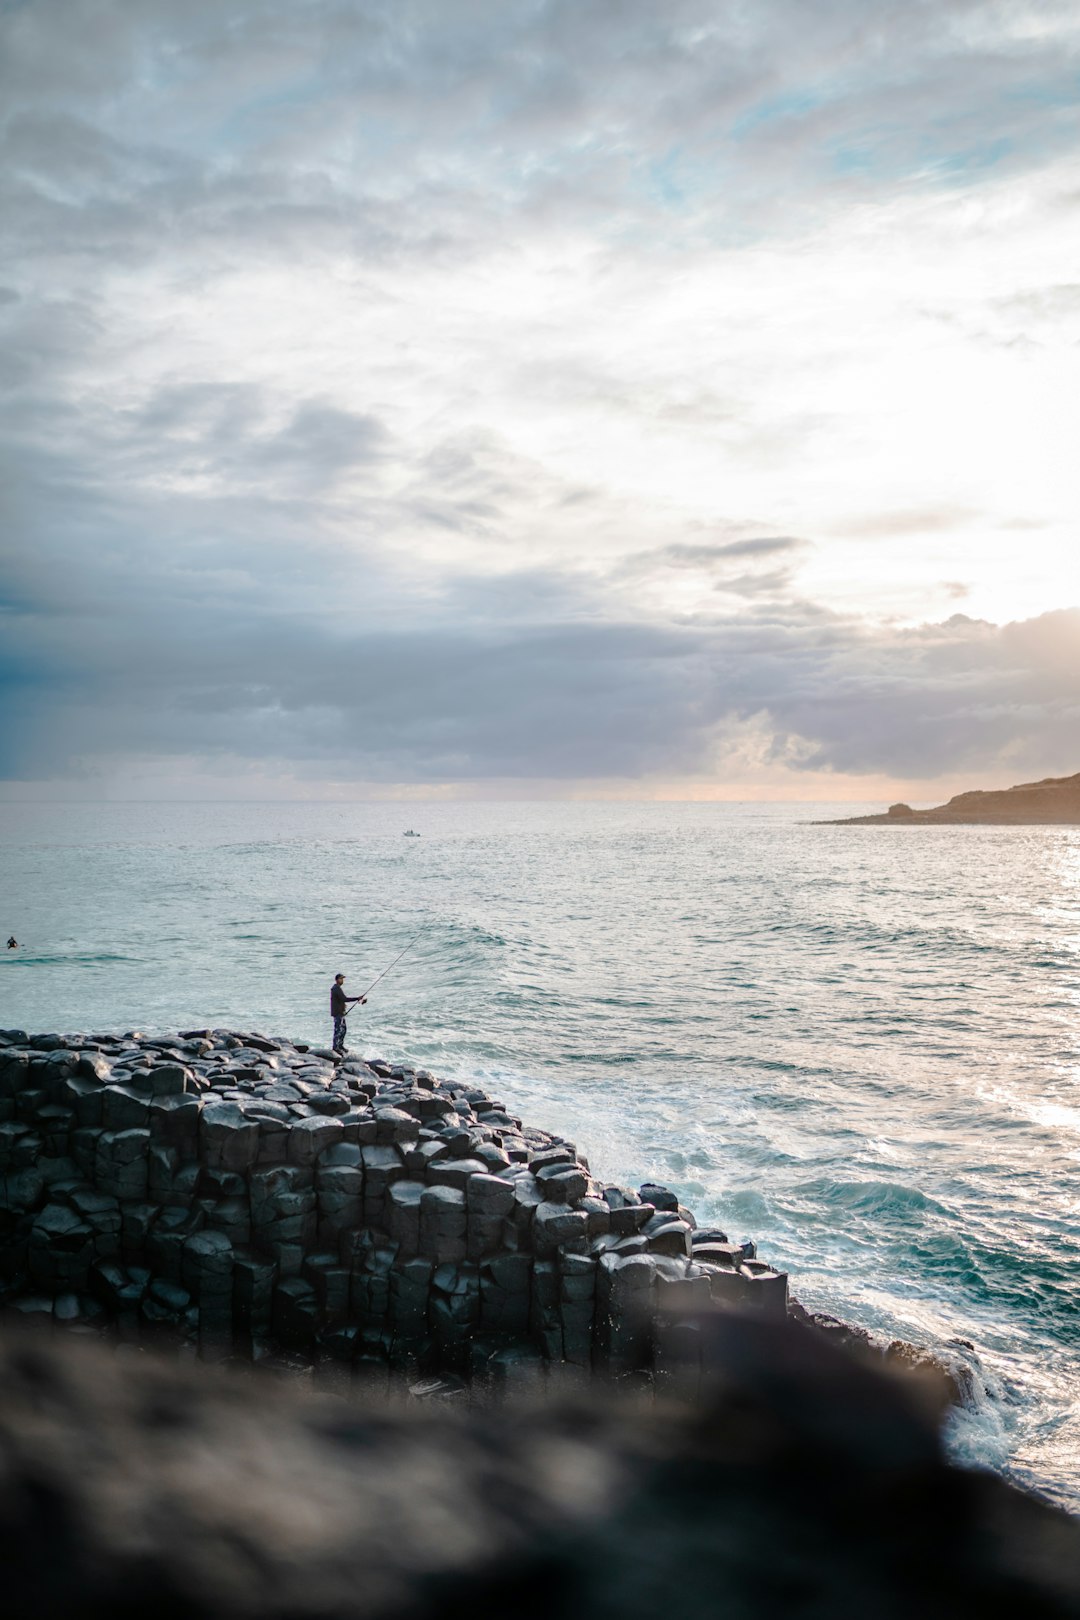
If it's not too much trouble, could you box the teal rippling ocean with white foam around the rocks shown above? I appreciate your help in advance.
[0,802,1080,1510]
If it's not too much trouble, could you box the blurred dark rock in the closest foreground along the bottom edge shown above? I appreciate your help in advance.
[0,1314,1080,1620]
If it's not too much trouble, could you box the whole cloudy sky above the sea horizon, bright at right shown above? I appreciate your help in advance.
[0,0,1080,802]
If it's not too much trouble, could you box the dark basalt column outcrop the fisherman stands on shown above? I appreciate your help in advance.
[0,1030,789,1387]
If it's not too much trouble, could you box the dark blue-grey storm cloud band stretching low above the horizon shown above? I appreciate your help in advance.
[0,447,1080,782]
